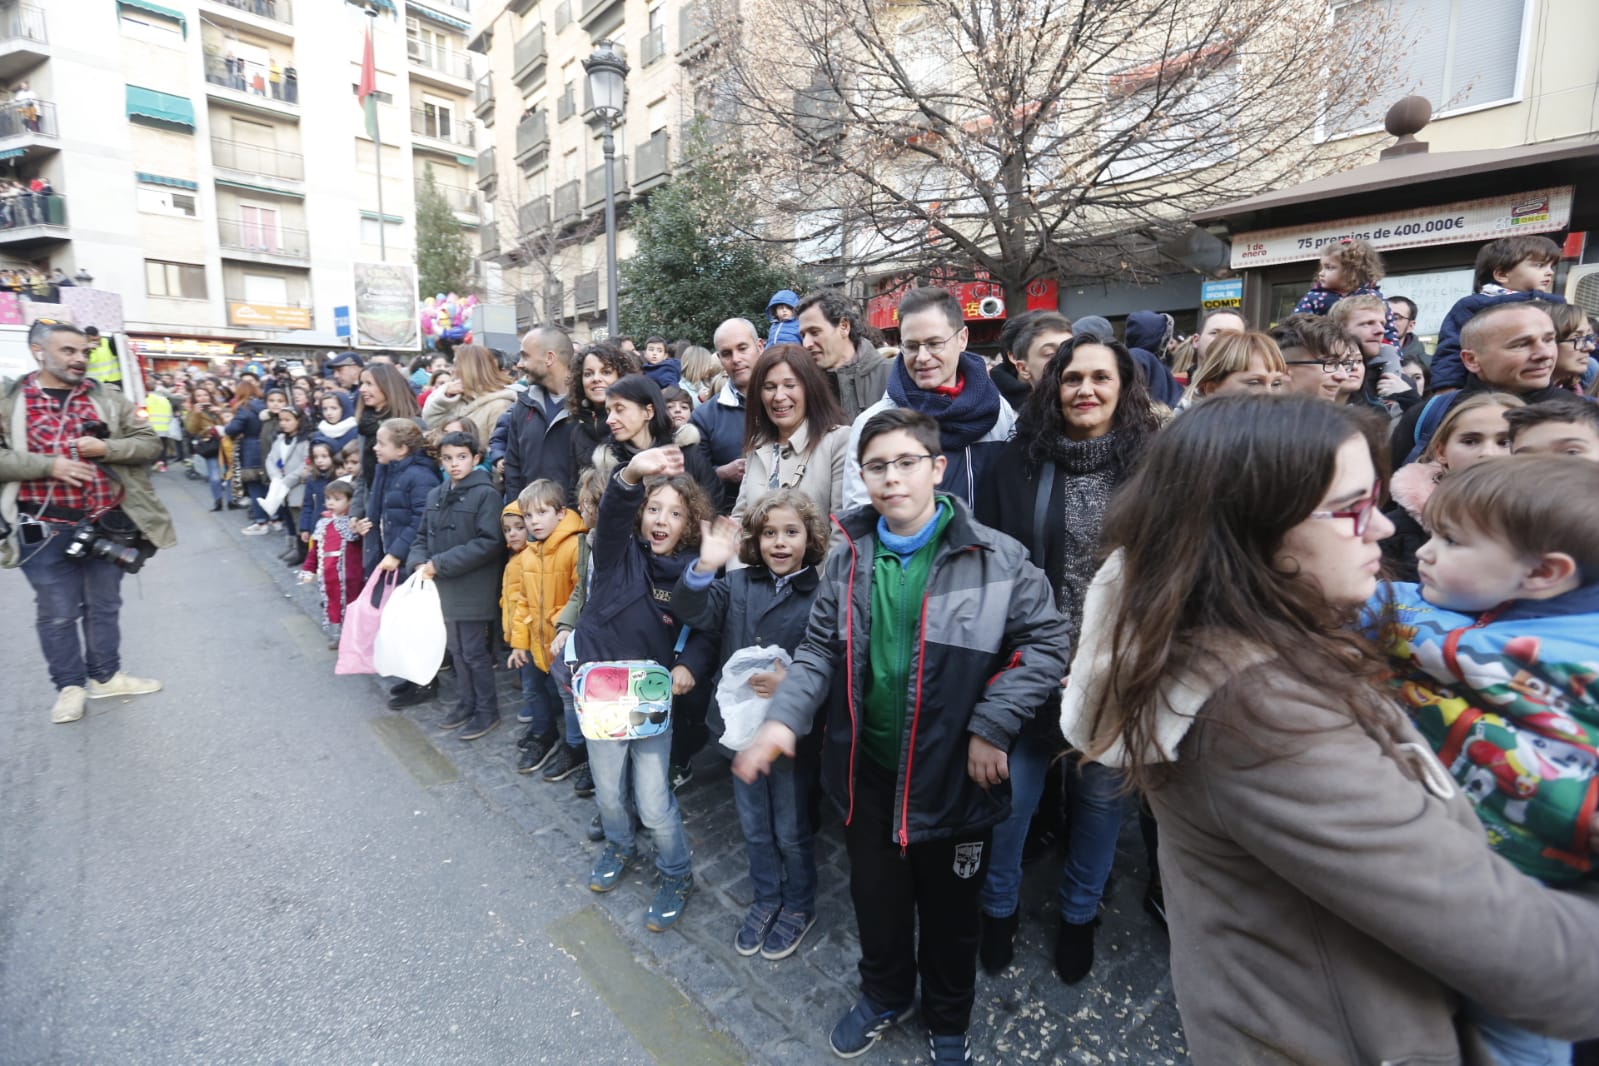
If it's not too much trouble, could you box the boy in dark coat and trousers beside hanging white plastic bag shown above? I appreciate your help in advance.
[406,430,504,740]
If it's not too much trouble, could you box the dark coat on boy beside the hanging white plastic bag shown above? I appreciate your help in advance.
[406,470,505,622]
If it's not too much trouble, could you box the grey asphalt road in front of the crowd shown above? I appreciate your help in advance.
[0,471,724,1066]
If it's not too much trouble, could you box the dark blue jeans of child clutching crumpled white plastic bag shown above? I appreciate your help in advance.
[732,759,815,914]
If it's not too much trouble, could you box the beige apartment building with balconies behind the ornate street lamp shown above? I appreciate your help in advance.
[470,0,707,337]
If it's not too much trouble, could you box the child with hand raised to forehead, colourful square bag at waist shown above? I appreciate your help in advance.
[566,447,716,933]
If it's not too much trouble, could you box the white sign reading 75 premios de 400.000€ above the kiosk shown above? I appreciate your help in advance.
[1233,185,1572,270]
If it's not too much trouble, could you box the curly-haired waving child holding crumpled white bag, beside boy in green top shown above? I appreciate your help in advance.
[672,489,827,959]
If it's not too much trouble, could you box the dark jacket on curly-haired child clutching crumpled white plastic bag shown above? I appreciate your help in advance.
[672,566,822,751]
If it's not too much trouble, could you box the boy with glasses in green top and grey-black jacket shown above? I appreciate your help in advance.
[734,405,1070,1063]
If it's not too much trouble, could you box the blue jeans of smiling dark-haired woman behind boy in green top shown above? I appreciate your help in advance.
[980,734,1121,924]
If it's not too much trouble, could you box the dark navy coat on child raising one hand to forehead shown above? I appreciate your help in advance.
[572,475,716,686]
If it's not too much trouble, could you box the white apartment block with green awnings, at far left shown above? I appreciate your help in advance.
[0,0,480,353]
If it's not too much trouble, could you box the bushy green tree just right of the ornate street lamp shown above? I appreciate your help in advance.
[617,129,801,347]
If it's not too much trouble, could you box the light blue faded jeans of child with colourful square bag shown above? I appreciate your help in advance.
[588,732,692,877]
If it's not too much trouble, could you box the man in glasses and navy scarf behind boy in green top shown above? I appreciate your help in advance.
[843,288,1015,511]
